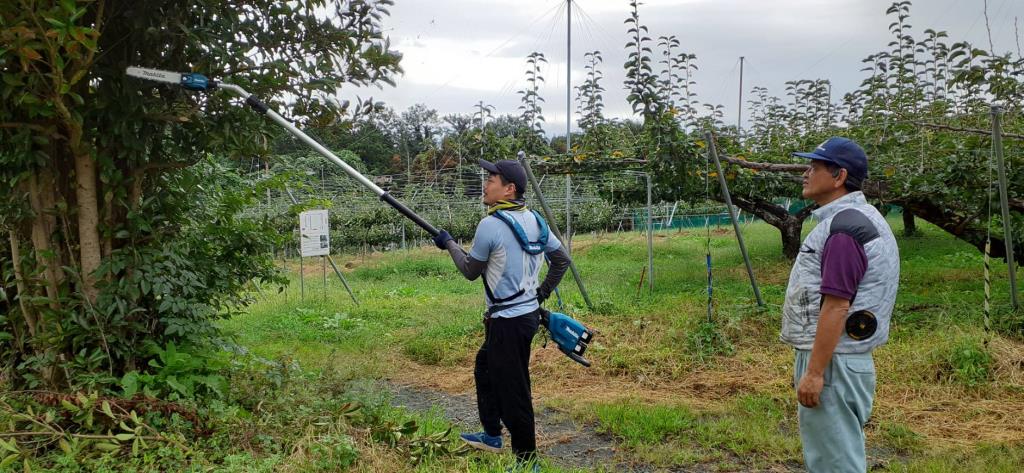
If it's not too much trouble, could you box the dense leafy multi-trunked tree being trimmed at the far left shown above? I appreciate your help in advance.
[0,0,400,389]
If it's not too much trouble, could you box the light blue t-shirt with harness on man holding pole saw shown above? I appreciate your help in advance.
[469,211,562,317]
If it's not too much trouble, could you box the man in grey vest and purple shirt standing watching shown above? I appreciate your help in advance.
[780,137,899,473]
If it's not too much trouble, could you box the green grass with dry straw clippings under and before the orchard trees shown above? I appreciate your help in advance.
[223,218,1024,471]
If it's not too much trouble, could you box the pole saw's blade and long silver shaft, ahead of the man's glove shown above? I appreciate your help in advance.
[125,68,439,237]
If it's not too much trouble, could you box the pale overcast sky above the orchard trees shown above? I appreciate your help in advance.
[359,0,1024,134]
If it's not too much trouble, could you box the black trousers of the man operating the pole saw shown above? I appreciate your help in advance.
[473,311,540,460]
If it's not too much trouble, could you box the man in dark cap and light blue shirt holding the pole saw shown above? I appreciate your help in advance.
[434,160,569,471]
